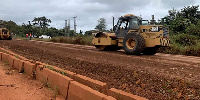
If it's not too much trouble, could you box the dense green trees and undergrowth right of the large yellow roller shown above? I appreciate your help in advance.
[159,6,200,56]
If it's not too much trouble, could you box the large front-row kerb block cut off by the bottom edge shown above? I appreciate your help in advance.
[67,81,116,100]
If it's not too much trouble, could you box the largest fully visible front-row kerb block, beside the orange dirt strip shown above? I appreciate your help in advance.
[36,65,73,97]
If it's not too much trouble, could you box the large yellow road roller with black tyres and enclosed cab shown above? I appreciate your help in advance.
[92,14,170,55]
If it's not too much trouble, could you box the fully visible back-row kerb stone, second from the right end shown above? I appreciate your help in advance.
[73,74,108,93]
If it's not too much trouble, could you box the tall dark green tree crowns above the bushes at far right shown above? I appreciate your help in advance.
[161,6,200,34]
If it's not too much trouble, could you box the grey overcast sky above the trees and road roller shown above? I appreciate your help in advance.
[0,0,200,32]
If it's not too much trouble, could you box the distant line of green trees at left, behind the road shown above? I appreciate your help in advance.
[0,16,81,37]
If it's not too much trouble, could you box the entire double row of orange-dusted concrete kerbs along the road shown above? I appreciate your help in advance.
[0,48,147,100]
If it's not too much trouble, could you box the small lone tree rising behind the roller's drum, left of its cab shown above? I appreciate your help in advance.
[95,18,106,31]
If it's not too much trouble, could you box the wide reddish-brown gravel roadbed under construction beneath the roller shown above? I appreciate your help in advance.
[0,40,200,100]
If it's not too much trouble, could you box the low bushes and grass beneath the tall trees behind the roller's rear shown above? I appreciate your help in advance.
[158,34,200,56]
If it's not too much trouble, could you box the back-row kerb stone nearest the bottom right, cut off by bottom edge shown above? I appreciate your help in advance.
[107,88,148,100]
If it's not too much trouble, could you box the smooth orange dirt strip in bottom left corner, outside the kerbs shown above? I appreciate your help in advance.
[0,62,64,100]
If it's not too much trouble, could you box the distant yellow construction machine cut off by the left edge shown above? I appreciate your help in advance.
[0,24,12,40]
